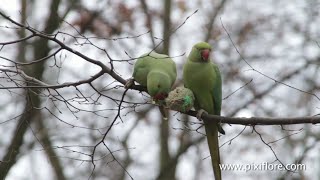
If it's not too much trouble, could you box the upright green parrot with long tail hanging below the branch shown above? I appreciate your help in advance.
[183,42,225,180]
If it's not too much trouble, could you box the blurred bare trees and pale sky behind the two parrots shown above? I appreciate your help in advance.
[0,0,320,180]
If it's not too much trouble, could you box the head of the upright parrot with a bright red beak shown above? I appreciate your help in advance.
[189,42,212,62]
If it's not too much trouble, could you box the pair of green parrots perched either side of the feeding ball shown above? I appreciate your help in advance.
[129,42,224,180]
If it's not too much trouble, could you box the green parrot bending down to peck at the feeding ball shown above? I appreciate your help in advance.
[126,52,177,115]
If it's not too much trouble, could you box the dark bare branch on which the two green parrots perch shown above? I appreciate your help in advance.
[0,11,320,132]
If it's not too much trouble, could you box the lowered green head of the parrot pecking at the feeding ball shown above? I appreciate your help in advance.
[147,72,172,101]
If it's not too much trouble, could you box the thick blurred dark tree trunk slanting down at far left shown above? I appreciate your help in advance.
[0,0,65,179]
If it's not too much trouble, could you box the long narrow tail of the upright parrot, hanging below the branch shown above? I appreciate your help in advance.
[204,121,221,180]
